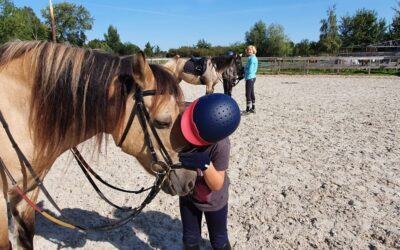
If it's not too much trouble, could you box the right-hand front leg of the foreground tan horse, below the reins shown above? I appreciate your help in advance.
[10,187,39,249]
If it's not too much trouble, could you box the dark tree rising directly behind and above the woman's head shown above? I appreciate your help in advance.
[245,20,267,56]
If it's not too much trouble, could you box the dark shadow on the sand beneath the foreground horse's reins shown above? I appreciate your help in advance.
[36,202,211,250]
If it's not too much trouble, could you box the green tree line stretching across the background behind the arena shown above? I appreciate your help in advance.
[0,0,400,57]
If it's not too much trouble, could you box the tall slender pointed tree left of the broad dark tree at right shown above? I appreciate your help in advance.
[319,5,342,54]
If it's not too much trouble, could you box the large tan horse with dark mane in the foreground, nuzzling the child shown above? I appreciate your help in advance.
[0,41,196,249]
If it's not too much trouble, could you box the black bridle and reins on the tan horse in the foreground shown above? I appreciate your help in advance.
[0,81,182,232]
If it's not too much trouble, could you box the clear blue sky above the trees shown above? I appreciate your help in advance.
[13,0,398,50]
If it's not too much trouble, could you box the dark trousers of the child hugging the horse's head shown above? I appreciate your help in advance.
[179,197,228,249]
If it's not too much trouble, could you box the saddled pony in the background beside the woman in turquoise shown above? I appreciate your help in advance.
[164,55,244,94]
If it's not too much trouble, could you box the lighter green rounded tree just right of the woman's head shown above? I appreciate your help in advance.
[265,24,293,56]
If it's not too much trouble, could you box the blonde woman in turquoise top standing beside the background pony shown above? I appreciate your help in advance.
[244,45,258,113]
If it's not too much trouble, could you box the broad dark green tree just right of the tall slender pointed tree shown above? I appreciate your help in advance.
[339,9,386,47]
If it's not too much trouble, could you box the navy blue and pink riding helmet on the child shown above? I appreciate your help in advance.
[181,93,240,146]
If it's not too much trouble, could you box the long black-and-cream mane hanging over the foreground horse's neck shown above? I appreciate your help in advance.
[0,41,126,166]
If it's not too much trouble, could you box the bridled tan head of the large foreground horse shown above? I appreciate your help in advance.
[112,52,196,195]
